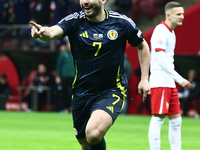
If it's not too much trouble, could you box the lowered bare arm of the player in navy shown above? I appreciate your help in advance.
[137,40,150,102]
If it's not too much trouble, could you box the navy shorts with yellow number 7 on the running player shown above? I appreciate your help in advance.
[72,90,126,139]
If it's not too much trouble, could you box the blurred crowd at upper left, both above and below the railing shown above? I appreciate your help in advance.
[0,0,81,52]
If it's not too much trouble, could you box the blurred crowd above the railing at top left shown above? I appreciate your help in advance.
[0,0,81,25]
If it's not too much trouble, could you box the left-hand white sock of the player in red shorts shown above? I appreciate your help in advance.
[148,117,164,150]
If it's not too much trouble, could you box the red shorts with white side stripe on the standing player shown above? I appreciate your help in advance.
[151,87,180,115]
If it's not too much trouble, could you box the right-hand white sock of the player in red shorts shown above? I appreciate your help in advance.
[169,116,182,150]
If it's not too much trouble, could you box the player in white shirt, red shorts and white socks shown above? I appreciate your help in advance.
[148,2,191,150]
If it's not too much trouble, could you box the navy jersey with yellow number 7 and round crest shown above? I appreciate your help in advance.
[57,10,143,96]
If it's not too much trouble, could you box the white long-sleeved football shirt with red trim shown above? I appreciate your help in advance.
[150,22,184,88]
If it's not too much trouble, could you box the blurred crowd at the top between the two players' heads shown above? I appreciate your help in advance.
[102,0,174,23]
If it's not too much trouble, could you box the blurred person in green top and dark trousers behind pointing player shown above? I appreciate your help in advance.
[55,37,75,112]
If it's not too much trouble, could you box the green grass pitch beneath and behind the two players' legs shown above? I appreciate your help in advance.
[0,111,200,150]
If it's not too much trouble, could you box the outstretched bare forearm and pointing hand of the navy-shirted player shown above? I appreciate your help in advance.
[30,21,64,41]
